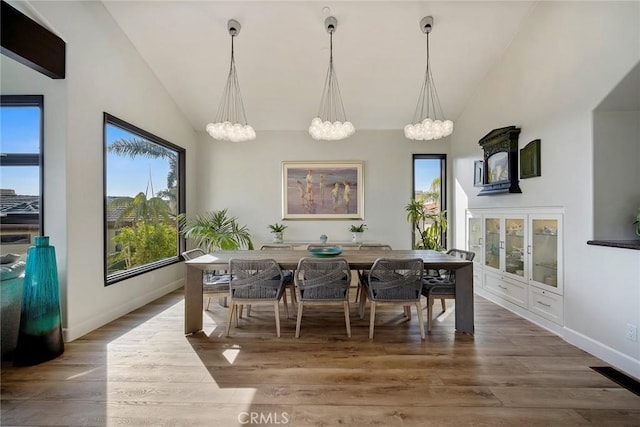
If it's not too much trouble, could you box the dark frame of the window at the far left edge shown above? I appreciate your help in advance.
[0,95,46,236]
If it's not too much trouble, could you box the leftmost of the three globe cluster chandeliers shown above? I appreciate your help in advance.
[207,19,256,142]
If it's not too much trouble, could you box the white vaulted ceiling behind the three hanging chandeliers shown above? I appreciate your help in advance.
[103,1,533,131]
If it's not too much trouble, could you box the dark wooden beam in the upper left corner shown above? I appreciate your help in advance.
[0,1,66,79]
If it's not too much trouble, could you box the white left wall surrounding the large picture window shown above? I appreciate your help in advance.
[2,2,196,340]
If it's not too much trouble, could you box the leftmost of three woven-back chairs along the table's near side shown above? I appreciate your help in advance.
[226,258,289,337]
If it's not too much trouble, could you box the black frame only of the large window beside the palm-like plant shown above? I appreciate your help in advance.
[102,112,187,286]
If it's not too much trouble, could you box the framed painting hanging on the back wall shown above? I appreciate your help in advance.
[282,160,364,220]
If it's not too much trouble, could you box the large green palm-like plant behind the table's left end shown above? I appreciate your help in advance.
[178,209,253,252]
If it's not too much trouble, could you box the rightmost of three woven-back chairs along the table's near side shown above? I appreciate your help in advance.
[365,258,425,339]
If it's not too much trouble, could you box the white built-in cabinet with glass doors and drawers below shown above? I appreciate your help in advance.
[466,208,564,325]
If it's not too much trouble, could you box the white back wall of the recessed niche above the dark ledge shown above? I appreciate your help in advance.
[593,111,640,240]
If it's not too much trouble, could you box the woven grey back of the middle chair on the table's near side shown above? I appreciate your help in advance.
[294,257,351,301]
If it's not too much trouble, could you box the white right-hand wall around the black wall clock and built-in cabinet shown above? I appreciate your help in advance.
[452,2,640,377]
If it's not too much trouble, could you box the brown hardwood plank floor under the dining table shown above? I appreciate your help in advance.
[0,291,640,427]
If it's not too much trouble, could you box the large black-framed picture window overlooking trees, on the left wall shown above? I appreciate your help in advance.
[104,113,185,285]
